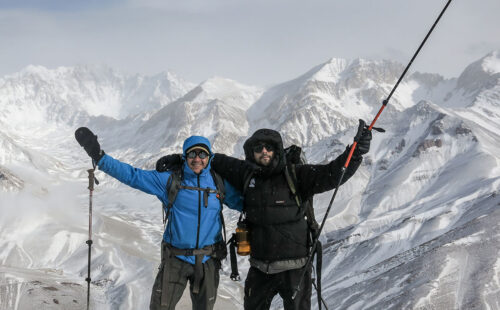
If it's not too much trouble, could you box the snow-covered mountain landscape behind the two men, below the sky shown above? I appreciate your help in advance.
[0,51,500,310]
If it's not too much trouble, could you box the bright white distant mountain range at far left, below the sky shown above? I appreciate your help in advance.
[0,66,196,128]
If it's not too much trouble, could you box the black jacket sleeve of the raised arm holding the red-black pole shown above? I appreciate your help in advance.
[295,147,362,197]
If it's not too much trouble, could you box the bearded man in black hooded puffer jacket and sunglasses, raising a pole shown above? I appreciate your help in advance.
[207,126,371,310]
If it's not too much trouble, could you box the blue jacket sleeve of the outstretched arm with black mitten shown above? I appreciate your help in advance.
[98,154,170,201]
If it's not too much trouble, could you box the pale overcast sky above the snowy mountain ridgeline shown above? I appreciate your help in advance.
[0,0,500,86]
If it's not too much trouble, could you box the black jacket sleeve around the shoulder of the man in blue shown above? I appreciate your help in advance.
[210,153,254,191]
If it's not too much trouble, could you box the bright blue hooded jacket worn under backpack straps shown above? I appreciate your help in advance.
[98,136,243,265]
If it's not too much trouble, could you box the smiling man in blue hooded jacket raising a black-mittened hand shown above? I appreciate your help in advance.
[75,127,242,310]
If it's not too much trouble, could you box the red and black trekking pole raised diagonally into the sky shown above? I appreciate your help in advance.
[292,0,451,299]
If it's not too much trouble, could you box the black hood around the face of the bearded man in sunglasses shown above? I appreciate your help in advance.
[243,128,286,174]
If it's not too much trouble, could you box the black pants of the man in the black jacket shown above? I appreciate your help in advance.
[244,267,312,310]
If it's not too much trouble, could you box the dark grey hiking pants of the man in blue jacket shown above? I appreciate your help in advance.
[149,256,221,310]
